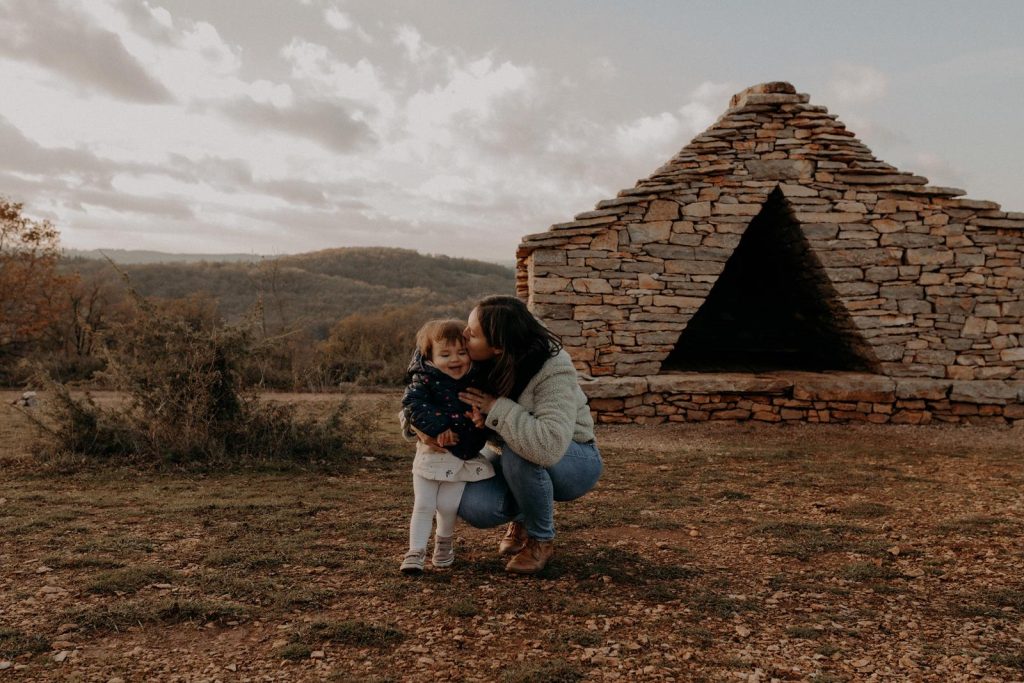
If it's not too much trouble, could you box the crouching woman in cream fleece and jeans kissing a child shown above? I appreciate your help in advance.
[459,296,602,573]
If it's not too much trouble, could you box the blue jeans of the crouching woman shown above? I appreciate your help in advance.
[459,441,603,541]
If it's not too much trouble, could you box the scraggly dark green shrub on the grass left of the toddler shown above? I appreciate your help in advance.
[29,288,376,465]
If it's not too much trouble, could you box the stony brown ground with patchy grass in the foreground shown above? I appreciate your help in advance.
[0,393,1024,682]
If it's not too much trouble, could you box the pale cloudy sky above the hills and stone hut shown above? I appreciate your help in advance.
[0,0,1024,261]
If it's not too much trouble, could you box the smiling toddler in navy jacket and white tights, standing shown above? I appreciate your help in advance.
[401,321,495,573]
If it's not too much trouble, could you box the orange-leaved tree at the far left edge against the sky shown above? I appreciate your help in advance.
[0,198,70,366]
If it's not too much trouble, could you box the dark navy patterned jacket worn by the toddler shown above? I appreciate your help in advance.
[401,351,489,460]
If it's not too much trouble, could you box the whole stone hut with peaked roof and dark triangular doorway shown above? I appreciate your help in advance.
[516,83,1024,424]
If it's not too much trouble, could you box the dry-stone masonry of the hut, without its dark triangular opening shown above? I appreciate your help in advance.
[517,83,1024,422]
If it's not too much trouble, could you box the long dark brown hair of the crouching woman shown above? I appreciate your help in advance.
[476,295,562,397]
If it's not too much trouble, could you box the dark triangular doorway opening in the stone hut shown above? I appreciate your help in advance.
[662,189,878,372]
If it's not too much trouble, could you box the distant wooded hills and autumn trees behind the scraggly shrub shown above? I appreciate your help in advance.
[7,248,514,390]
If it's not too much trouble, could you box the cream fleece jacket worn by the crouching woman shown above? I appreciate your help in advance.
[486,350,594,467]
